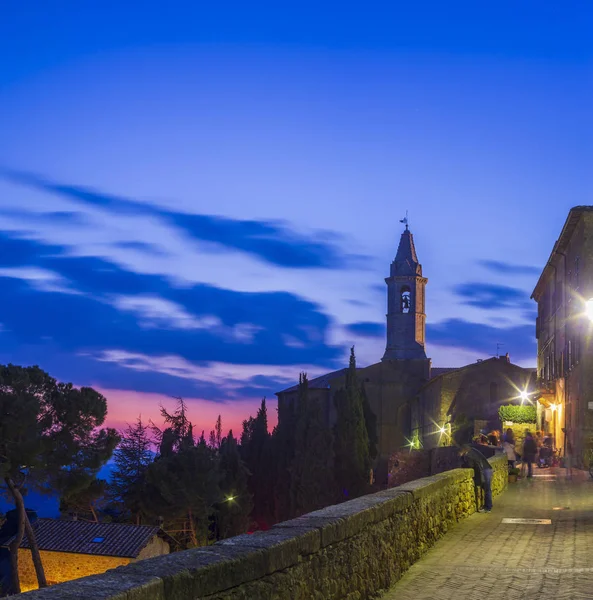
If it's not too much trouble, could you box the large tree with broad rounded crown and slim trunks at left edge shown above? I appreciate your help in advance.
[0,364,118,593]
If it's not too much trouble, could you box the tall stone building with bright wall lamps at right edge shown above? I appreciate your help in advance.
[531,206,593,466]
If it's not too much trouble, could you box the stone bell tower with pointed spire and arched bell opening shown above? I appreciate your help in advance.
[382,219,428,360]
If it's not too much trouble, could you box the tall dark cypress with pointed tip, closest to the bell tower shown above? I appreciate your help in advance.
[334,347,371,498]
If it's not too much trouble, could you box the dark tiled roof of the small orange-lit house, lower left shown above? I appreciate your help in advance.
[3,519,159,558]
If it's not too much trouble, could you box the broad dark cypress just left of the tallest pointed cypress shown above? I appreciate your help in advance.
[290,373,335,516]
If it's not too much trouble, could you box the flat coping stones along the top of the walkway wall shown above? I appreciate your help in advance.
[20,456,507,600]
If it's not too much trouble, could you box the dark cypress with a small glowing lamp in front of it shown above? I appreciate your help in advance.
[217,430,253,539]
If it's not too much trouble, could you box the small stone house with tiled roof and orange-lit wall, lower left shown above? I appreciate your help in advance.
[0,511,169,592]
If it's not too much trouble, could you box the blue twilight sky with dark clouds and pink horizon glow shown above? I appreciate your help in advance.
[0,0,593,434]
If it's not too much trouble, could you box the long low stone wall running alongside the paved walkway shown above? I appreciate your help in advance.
[26,457,507,600]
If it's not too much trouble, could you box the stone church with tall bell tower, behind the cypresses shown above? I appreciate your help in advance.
[276,224,534,476]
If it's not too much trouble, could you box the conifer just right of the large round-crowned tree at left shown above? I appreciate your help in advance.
[109,417,153,525]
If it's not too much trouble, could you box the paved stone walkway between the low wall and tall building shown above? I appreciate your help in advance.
[382,469,593,600]
